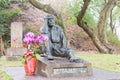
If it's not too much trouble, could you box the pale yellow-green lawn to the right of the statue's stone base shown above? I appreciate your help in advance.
[76,54,120,73]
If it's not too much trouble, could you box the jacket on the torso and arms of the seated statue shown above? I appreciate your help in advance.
[40,25,66,47]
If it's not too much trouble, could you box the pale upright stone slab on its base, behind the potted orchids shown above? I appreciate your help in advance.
[6,22,27,60]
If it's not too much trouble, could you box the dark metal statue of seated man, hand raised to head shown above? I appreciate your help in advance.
[40,14,83,62]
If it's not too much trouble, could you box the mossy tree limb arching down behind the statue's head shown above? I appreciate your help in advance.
[29,0,64,29]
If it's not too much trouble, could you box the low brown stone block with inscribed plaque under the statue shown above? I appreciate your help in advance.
[36,57,92,77]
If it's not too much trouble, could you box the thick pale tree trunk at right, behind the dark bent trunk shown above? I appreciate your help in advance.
[97,0,117,44]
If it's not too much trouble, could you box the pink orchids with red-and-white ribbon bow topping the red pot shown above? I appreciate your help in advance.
[22,32,48,63]
